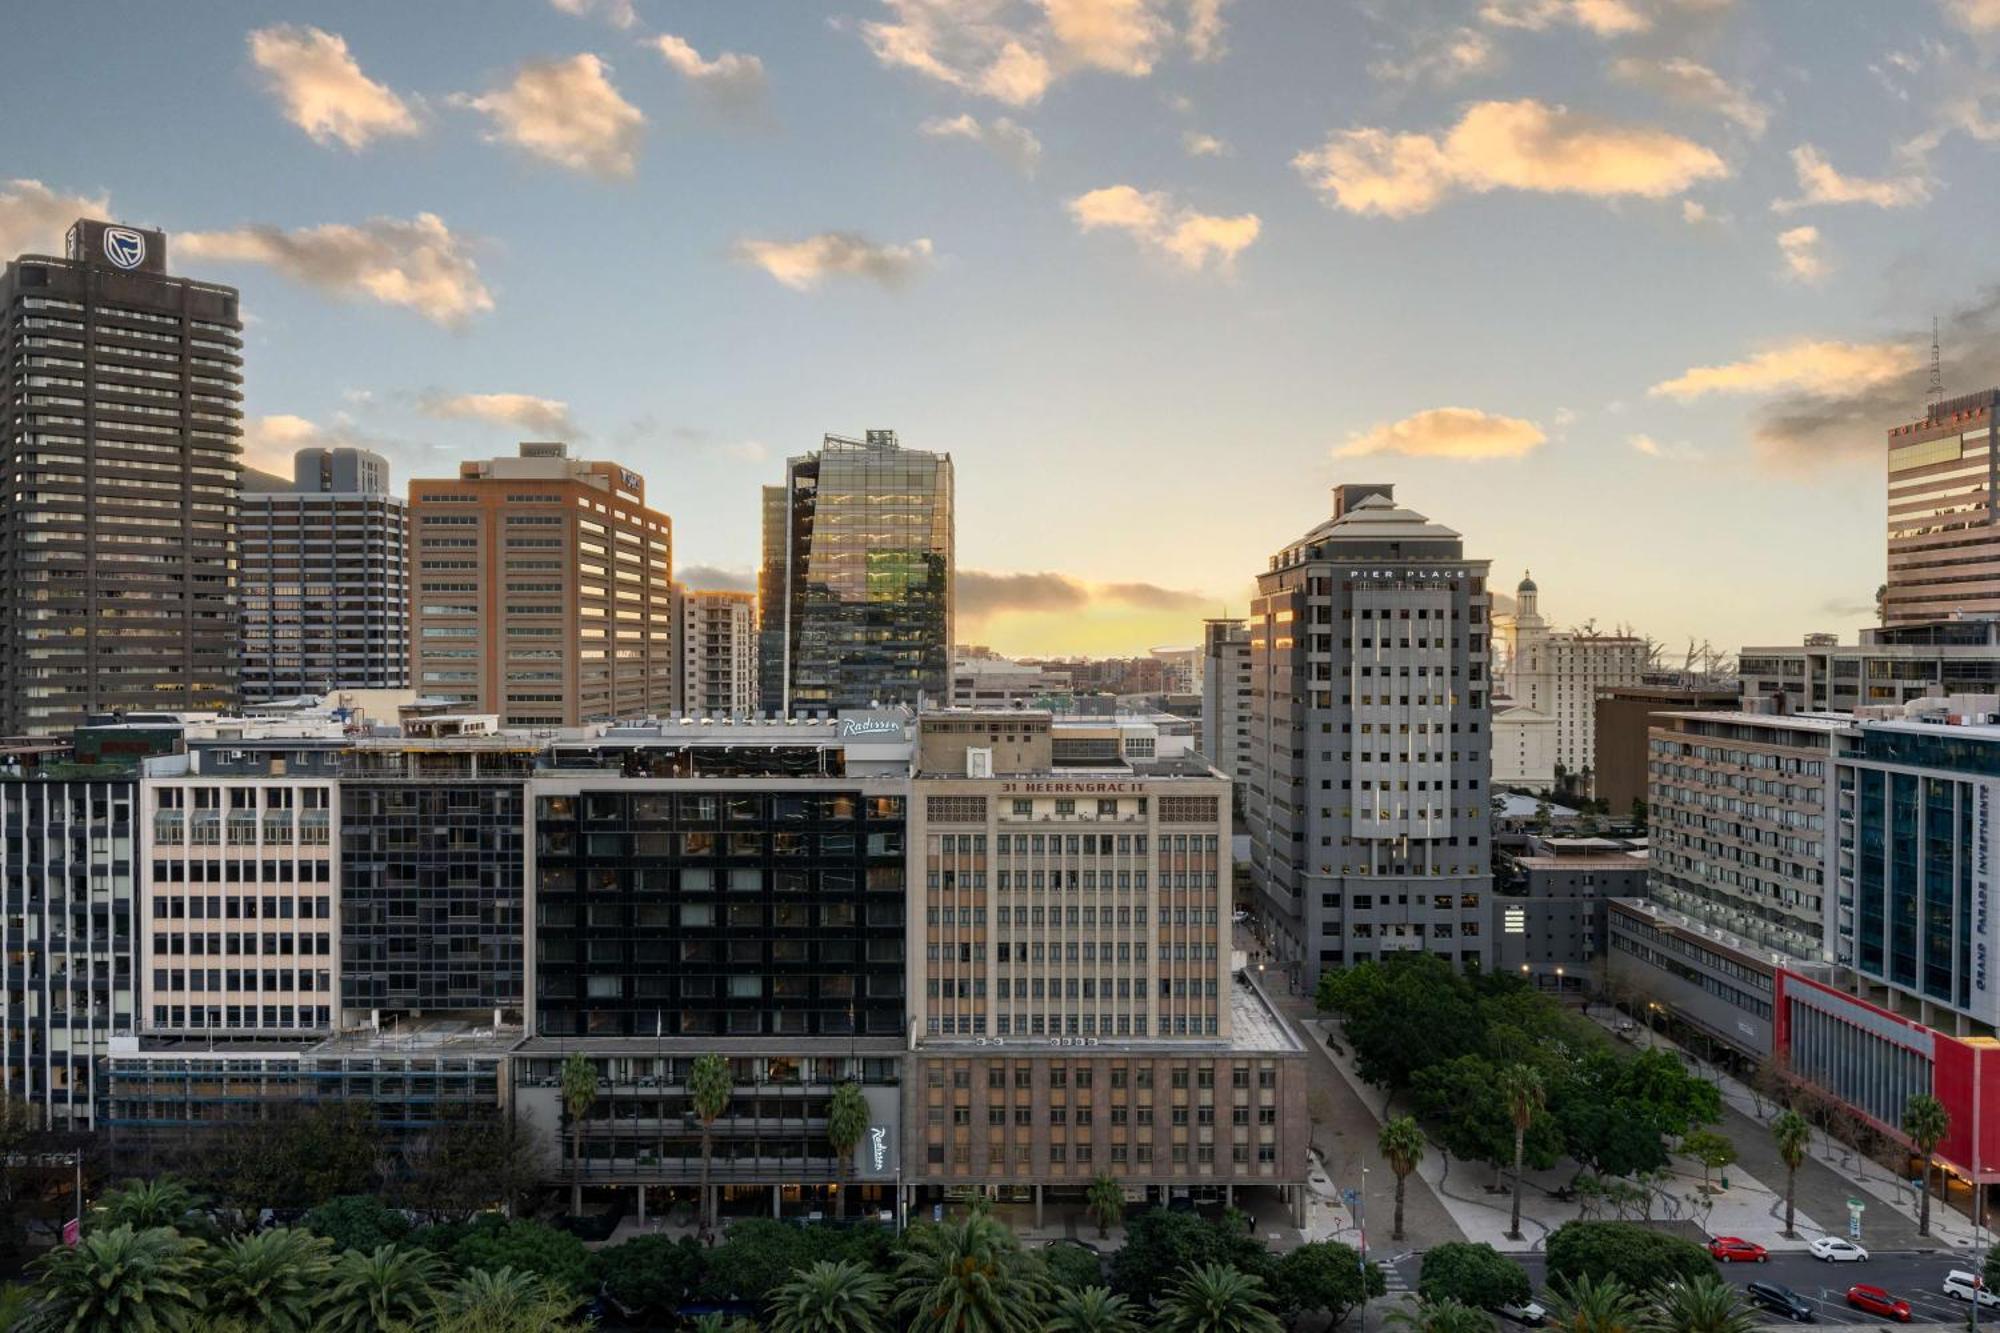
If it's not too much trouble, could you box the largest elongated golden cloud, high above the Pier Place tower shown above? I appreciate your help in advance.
[1292,100,1730,218]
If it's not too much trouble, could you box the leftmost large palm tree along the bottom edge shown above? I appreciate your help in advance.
[20,1225,204,1333]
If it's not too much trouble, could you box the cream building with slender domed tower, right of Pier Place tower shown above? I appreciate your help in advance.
[1494,576,1648,793]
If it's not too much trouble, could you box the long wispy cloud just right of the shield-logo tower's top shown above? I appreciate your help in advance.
[174,212,494,328]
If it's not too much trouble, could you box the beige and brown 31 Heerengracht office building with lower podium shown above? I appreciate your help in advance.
[904,709,1306,1207]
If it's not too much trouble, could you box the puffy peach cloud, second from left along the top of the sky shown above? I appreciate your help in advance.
[452,52,646,180]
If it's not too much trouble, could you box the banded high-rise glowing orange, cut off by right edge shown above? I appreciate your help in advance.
[1882,388,2000,624]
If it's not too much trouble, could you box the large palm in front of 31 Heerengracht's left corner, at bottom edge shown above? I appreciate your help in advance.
[894,1211,1048,1333]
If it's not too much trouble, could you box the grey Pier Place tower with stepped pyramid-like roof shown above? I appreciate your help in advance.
[1244,484,1492,985]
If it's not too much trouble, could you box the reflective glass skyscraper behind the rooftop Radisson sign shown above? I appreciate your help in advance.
[760,430,952,715]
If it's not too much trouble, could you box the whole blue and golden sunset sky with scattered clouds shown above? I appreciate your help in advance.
[0,0,2000,656]
